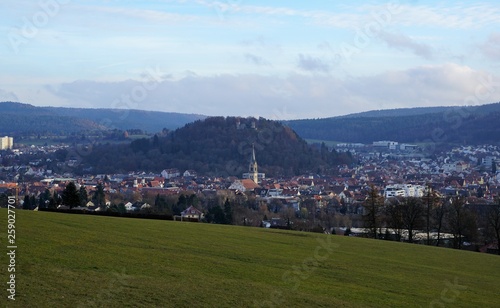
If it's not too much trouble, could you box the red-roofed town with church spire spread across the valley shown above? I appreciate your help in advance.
[0,137,500,251]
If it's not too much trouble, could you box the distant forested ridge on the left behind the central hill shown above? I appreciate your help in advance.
[0,102,205,134]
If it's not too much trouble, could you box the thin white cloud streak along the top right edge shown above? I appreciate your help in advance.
[197,0,500,29]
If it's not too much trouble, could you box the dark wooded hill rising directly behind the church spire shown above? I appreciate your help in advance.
[79,117,351,177]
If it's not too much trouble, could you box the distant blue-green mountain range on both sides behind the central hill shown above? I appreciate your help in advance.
[0,102,500,144]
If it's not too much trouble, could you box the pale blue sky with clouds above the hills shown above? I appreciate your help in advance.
[0,0,500,120]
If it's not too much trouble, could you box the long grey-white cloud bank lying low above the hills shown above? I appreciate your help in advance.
[38,63,500,119]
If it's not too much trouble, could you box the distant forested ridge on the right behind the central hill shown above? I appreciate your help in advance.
[286,103,500,144]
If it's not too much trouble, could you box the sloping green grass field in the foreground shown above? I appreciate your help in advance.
[0,209,500,307]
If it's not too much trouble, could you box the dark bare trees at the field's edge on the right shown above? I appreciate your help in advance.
[363,186,500,253]
